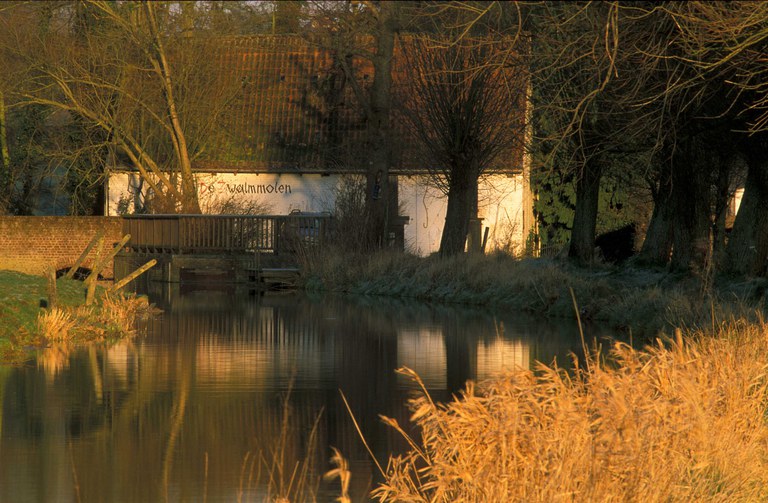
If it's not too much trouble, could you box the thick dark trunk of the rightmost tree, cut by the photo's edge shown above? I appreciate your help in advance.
[724,137,768,276]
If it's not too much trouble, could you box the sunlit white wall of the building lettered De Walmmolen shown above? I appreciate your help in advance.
[107,172,530,255]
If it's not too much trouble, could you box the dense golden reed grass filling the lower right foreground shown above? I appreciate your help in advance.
[374,321,768,502]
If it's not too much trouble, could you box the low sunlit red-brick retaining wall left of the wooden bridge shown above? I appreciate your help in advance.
[0,216,122,278]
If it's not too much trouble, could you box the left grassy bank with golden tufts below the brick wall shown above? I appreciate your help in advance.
[0,271,149,362]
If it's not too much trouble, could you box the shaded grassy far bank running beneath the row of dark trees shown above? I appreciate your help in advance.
[304,253,765,334]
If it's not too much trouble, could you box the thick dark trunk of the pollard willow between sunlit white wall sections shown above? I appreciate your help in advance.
[440,162,477,257]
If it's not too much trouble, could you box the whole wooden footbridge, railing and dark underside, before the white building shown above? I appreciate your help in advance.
[115,213,332,292]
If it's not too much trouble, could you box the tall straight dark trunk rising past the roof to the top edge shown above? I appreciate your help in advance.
[365,2,396,248]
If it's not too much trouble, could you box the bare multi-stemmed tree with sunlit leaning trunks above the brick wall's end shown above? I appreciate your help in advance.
[0,1,244,213]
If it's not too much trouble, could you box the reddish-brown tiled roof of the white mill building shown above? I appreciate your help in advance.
[193,35,522,174]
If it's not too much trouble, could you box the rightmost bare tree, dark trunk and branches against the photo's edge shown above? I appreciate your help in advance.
[666,2,768,276]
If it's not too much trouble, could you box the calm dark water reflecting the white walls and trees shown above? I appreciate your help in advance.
[0,289,612,503]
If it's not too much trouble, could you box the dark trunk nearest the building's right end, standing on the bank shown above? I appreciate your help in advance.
[568,154,603,265]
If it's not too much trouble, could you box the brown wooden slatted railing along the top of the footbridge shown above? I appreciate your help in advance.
[123,214,331,254]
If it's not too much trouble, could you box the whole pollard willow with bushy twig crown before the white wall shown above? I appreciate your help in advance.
[398,38,526,256]
